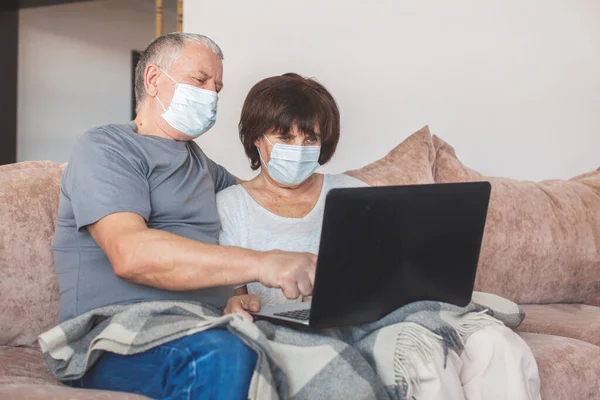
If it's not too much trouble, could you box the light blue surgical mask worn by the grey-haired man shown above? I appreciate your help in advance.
[156,68,219,138]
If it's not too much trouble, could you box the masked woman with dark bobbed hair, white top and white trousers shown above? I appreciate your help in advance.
[217,74,539,400]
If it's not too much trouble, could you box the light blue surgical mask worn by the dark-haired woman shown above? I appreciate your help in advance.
[257,135,321,186]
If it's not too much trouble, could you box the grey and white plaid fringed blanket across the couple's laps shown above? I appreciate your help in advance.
[39,292,524,400]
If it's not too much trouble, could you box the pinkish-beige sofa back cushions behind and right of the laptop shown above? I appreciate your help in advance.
[348,127,600,304]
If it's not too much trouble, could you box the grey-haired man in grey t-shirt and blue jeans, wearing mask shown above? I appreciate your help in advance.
[54,33,316,399]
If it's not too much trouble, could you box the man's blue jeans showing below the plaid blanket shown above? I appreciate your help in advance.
[69,329,257,400]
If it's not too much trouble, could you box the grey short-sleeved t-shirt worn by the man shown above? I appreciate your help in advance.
[53,122,235,322]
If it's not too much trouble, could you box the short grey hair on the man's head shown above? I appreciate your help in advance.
[134,32,223,111]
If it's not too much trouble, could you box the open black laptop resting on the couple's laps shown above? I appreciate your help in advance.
[253,182,491,329]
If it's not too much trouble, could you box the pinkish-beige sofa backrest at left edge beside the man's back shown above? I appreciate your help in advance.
[0,161,63,346]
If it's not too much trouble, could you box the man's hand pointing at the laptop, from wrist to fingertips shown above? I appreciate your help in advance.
[258,250,317,299]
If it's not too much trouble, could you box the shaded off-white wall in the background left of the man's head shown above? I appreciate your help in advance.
[17,0,176,161]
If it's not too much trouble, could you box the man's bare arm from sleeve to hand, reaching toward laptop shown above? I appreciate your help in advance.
[87,212,317,298]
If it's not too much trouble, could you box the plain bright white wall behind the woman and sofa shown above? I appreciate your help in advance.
[184,0,600,179]
